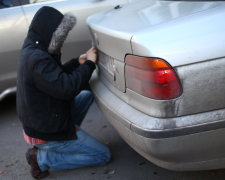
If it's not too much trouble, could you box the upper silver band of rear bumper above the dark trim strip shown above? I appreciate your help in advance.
[91,70,225,138]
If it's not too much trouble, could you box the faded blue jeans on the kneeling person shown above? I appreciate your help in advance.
[35,90,111,171]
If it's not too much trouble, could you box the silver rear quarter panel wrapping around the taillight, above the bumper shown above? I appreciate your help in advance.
[131,3,225,117]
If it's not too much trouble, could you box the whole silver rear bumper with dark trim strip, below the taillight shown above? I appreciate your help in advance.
[91,71,225,170]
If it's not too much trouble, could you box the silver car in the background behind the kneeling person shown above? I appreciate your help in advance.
[0,0,129,100]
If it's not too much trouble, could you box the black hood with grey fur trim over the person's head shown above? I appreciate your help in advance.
[28,6,76,54]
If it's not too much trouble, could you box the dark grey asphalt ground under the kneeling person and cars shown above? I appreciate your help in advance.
[0,96,225,180]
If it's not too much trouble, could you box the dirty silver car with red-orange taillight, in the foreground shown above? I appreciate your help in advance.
[88,0,225,171]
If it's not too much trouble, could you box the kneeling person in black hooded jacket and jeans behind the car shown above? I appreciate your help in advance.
[17,6,111,179]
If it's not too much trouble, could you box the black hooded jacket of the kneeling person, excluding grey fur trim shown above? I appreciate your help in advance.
[17,7,95,141]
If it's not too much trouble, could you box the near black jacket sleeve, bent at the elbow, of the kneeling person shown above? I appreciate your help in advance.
[32,56,95,100]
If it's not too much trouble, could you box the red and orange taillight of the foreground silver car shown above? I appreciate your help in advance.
[125,55,182,100]
